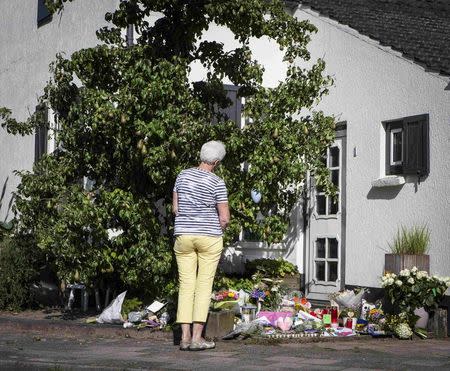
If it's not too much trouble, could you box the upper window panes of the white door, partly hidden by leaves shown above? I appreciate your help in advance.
[316,147,340,215]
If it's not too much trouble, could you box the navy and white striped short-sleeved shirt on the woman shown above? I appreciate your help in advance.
[173,168,228,236]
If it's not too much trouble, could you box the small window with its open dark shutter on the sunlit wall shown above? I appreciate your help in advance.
[383,114,429,176]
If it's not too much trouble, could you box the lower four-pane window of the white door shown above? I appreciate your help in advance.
[314,238,339,282]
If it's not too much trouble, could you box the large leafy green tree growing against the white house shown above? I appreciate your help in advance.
[0,0,334,295]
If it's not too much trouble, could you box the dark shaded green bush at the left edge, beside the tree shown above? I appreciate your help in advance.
[0,236,42,311]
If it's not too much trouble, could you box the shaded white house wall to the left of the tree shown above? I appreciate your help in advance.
[0,0,119,220]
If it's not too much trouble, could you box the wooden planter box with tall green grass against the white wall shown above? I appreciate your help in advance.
[384,225,430,274]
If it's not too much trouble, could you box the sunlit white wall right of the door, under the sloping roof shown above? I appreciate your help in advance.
[296,9,450,287]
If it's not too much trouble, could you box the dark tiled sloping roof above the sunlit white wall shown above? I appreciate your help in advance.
[298,0,450,76]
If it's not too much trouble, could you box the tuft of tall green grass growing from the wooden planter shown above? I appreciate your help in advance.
[389,225,430,255]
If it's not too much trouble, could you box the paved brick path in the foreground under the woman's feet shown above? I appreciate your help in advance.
[0,317,450,371]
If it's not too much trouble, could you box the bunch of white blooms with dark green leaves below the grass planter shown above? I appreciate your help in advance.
[381,267,450,312]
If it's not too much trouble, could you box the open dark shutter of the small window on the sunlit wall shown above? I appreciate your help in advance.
[403,115,429,176]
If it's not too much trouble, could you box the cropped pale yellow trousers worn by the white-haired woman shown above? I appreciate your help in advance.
[174,235,223,323]
